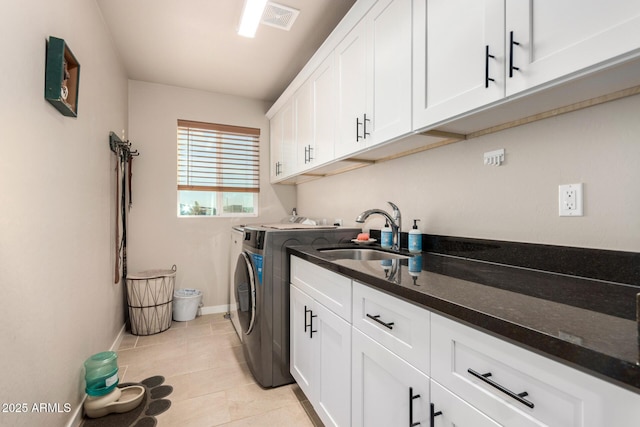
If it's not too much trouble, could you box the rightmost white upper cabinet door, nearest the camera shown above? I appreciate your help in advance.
[506,0,640,95]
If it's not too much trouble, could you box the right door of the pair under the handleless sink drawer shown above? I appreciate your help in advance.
[312,303,351,426]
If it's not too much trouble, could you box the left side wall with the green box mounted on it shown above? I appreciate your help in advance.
[0,0,127,426]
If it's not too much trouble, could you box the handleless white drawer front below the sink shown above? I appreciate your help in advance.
[290,256,351,323]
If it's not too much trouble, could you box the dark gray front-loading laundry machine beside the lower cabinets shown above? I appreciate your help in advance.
[231,226,360,388]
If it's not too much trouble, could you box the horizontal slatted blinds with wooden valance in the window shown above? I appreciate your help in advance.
[178,120,260,193]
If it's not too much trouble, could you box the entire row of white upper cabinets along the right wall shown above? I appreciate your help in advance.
[267,0,640,182]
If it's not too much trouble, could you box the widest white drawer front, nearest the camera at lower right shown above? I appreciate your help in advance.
[431,314,640,427]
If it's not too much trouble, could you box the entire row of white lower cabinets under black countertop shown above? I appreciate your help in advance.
[290,257,640,427]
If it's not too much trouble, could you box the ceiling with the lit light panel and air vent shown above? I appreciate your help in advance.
[96,0,355,102]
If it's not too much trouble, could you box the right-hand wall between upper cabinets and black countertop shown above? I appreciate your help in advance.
[297,95,640,252]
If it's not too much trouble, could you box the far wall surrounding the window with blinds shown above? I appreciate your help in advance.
[128,81,295,311]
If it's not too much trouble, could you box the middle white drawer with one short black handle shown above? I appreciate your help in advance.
[353,282,430,375]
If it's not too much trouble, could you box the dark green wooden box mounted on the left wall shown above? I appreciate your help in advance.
[44,37,80,117]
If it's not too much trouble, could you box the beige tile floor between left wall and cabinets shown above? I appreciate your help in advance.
[118,314,322,427]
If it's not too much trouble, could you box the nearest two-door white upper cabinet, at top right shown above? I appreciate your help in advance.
[413,0,640,129]
